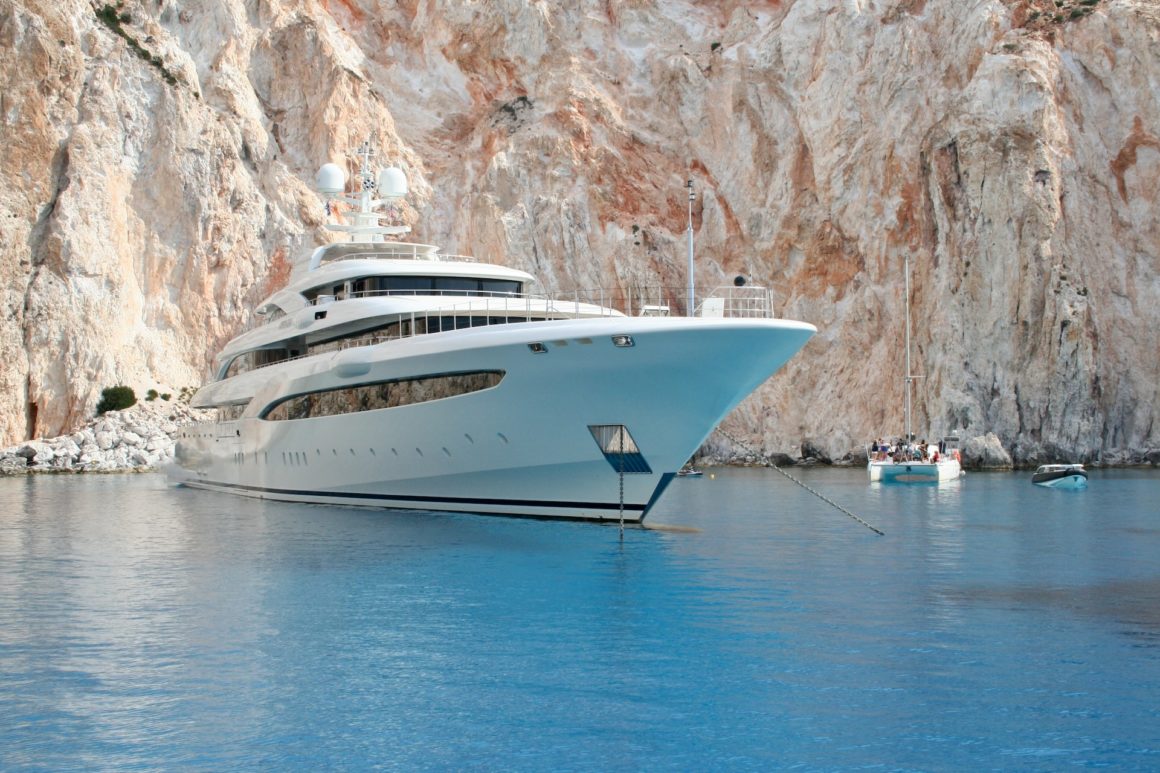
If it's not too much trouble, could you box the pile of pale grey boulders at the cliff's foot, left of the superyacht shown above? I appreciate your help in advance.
[0,402,213,475]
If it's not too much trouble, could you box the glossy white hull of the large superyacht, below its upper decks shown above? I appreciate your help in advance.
[174,317,814,522]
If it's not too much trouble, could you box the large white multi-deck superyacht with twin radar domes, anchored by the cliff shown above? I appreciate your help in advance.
[174,145,817,522]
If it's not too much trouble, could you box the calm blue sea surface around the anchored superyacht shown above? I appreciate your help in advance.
[0,469,1160,771]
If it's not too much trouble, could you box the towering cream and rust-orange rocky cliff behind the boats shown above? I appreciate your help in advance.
[0,0,1160,462]
